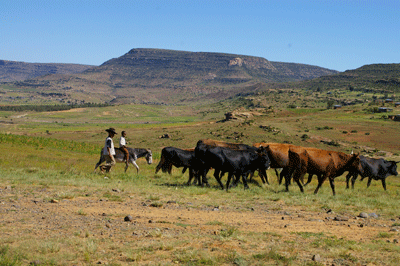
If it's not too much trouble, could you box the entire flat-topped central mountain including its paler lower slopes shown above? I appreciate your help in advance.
[0,49,338,104]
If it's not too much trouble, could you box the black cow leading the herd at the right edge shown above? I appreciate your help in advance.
[346,155,398,190]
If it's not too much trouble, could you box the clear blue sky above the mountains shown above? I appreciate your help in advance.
[0,0,400,71]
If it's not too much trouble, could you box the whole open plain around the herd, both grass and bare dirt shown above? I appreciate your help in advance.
[0,101,400,265]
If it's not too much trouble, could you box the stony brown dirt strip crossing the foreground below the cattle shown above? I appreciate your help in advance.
[0,185,398,265]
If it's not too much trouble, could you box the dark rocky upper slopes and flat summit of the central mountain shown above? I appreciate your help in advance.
[93,49,338,85]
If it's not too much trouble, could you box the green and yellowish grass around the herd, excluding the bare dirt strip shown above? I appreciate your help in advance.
[0,101,400,265]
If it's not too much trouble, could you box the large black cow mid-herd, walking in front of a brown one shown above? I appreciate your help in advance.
[195,140,270,189]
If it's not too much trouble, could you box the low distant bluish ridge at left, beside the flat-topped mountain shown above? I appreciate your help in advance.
[0,60,93,82]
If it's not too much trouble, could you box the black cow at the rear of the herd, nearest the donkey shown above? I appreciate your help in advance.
[156,147,198,185]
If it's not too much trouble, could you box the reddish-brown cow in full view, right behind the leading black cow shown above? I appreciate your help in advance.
[286,148,362,195]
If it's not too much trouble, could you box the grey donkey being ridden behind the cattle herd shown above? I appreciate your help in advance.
[94,147,153,173]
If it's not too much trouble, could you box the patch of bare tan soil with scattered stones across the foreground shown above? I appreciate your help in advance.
[0,184,399,265]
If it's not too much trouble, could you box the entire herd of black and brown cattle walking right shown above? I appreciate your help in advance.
[156,139,398,195]
